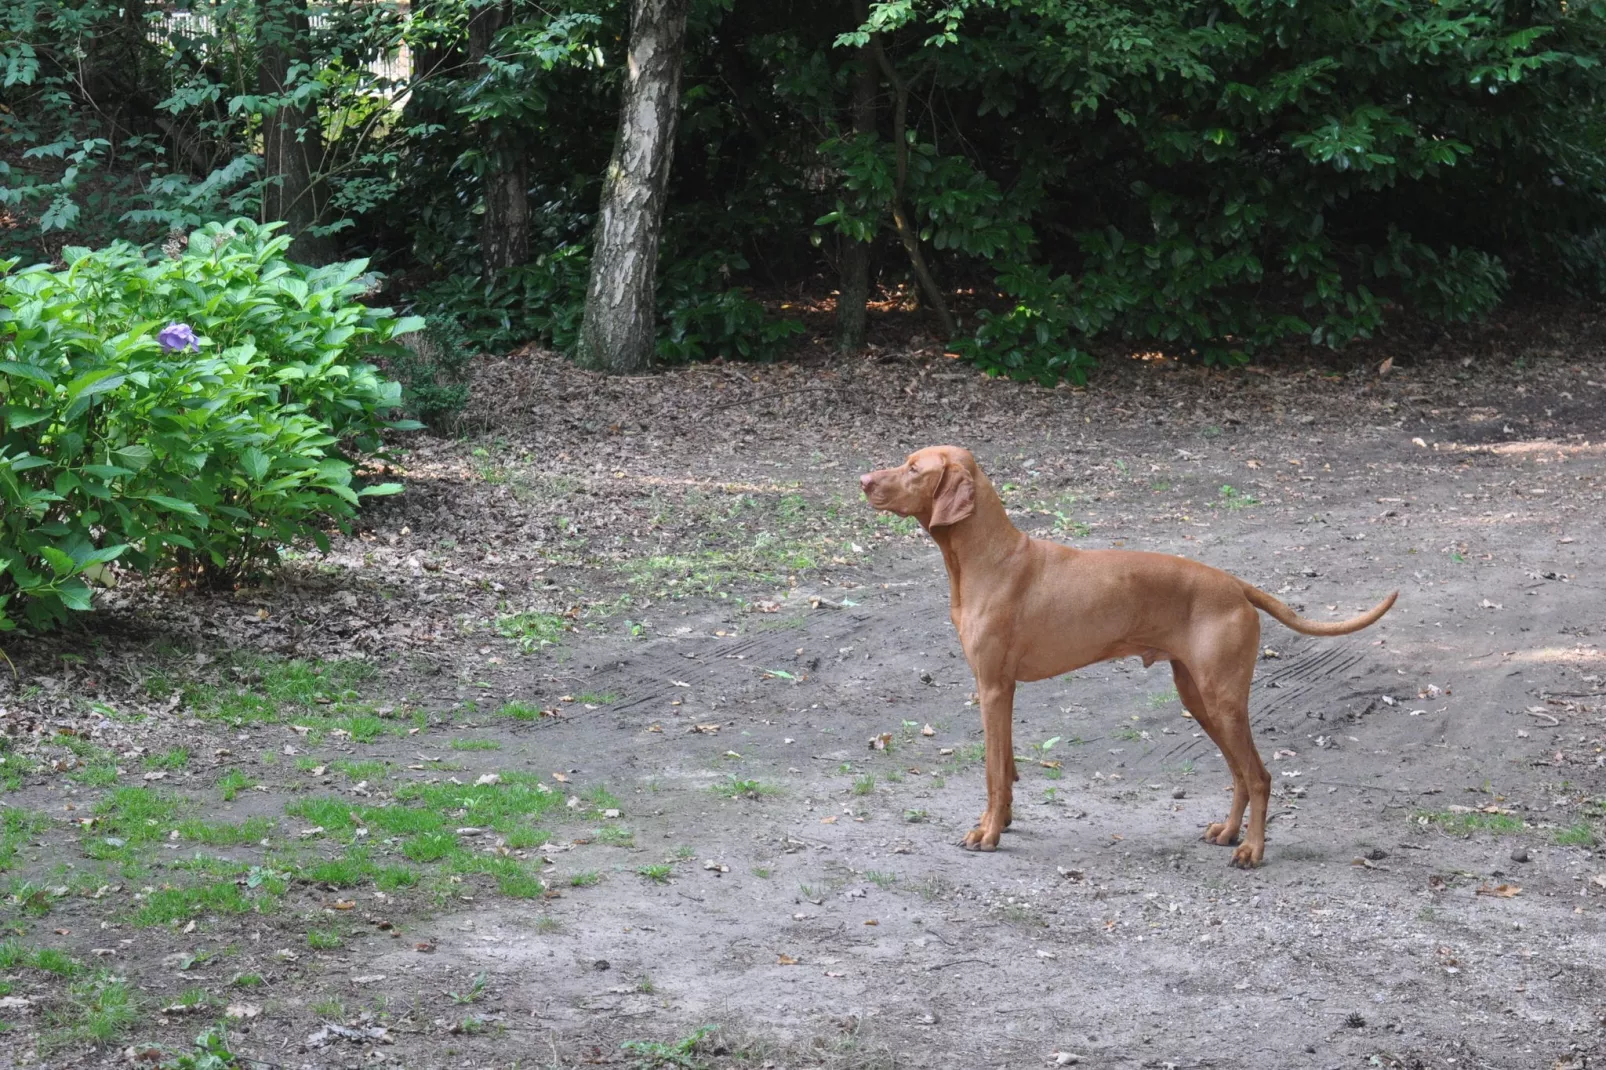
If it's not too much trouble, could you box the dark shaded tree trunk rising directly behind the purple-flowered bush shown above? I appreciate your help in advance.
[257,0,334,263]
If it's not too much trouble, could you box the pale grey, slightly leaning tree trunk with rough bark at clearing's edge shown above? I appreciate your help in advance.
[575,0,691,373]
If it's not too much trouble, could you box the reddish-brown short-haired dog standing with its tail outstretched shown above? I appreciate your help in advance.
[859,447,1399,868]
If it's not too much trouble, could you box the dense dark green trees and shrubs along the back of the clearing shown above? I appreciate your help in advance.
[0,0,1606,392]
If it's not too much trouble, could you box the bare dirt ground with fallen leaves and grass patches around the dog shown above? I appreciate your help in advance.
[0,310,1606,1070]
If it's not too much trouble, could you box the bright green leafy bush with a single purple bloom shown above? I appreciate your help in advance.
[0,220,422,628]
